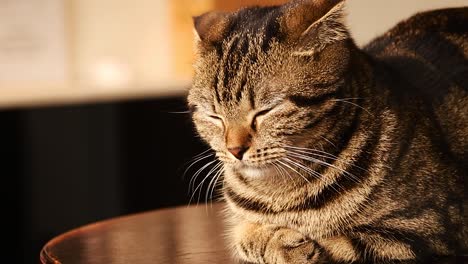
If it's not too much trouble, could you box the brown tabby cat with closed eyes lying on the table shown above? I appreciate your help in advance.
[187,0,468,264]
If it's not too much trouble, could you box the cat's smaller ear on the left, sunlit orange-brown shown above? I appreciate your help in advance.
[193,12,231,47]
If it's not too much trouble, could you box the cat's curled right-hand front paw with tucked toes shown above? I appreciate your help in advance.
[265,229,320,264]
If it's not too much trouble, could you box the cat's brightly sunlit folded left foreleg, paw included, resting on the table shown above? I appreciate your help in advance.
[232,222,323,264]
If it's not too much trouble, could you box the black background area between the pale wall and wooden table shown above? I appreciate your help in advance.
[0,96,208,263]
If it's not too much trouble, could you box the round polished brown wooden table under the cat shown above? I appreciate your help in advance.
[40,204,236,264]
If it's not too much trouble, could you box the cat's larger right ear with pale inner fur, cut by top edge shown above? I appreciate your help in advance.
[279,0,350,56]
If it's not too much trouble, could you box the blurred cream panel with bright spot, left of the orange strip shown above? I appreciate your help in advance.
[72,0,173,86]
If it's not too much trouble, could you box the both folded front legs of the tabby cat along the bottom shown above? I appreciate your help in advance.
[232,222,417,264]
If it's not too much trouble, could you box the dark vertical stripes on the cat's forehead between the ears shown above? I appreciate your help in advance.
[214,7,286,108]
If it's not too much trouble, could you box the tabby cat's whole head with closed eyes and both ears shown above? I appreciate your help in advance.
[188,0,353,177]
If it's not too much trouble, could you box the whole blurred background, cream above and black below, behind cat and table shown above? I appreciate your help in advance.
[0,0,467,263]
